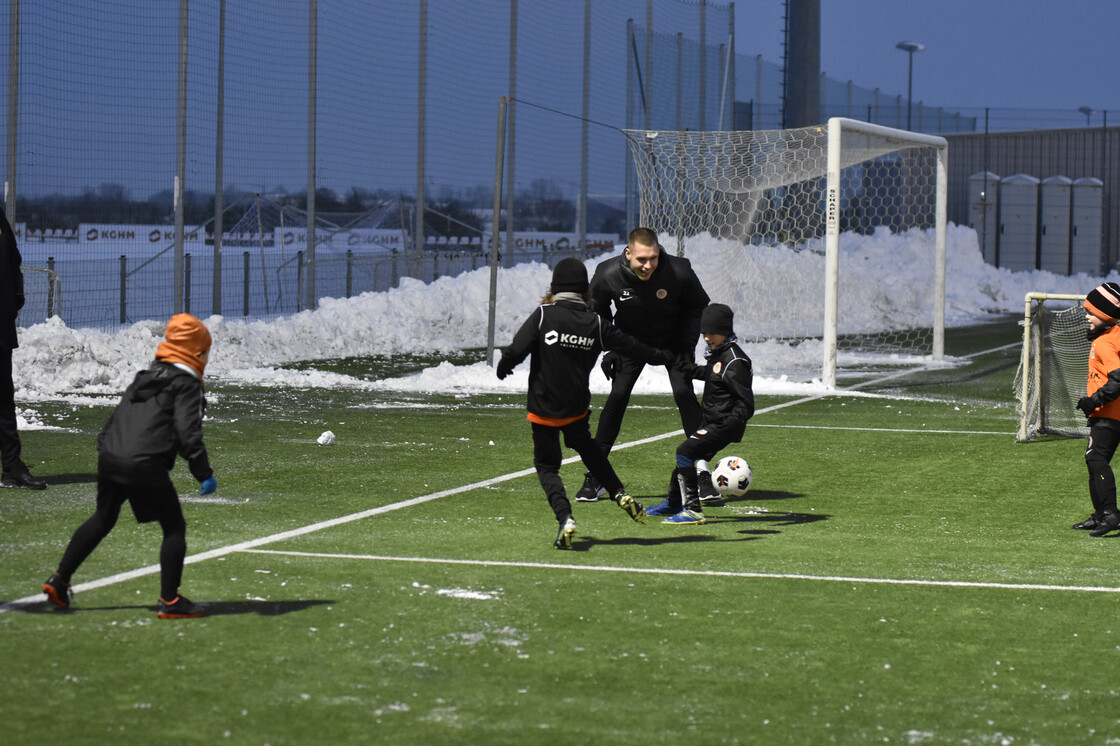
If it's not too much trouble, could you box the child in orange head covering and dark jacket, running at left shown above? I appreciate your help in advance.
[43,314,217,619]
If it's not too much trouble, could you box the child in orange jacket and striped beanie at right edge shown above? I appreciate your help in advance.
[1073,282,1120,537]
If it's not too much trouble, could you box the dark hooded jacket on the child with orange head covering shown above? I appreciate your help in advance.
[97,361,214,484]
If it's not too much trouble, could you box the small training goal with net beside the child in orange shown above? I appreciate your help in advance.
[1015,292,1091,442]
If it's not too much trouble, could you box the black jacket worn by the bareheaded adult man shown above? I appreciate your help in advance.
[588,249,708,357]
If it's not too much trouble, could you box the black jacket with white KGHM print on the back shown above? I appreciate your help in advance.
[497,300,673,419]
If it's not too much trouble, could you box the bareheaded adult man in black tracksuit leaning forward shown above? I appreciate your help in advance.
[576,227,718,502]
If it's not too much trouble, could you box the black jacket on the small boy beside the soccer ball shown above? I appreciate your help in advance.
[682,341,755,440]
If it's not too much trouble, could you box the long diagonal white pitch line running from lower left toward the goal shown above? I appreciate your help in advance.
[0,353,1007,614]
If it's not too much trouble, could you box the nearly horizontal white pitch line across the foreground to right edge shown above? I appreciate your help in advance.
[242,549,1120,594]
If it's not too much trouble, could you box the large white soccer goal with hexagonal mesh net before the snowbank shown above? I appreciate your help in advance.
[625,118,949,386]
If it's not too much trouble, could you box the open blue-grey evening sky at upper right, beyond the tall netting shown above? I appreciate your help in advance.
[735,0,1120,113]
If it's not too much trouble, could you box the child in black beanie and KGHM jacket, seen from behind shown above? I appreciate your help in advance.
[497,259,674,549]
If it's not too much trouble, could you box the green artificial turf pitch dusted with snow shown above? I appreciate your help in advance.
[0,320,1120,746]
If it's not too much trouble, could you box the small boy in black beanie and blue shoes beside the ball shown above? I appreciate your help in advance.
[646,304,755,525]
